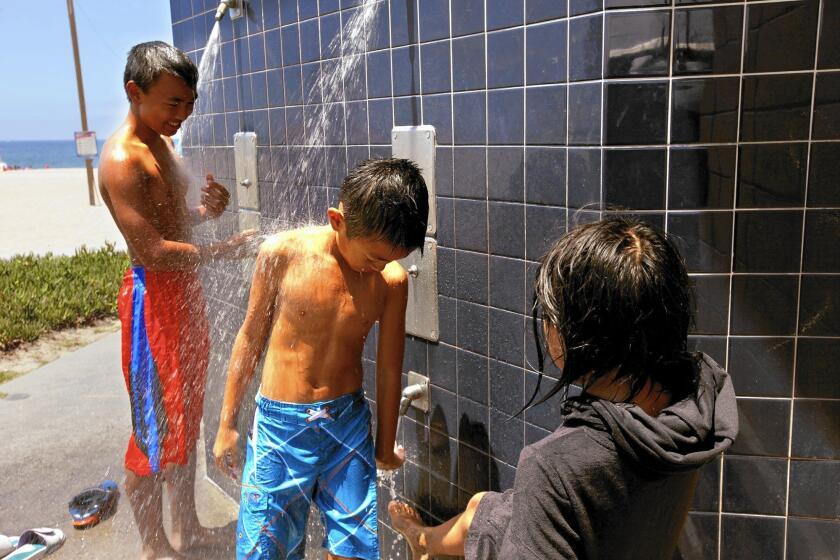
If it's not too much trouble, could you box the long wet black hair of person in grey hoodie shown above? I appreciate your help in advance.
[529,217,699,412]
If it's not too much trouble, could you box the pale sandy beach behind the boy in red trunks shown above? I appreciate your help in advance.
[0,168,125,259]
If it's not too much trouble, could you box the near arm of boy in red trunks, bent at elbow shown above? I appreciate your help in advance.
[100,156,249,270]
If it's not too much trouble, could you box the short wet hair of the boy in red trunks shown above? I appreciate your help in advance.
[123,41,198,101]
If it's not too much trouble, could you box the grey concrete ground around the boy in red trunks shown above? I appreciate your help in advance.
[0,333,238,560]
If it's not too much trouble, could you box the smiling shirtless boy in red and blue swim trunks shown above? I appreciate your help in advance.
[99,42,249,560]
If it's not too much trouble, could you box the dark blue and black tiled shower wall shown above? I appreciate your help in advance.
[171,0,840,559]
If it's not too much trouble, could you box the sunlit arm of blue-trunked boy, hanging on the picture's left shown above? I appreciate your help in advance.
[213,243,283,478]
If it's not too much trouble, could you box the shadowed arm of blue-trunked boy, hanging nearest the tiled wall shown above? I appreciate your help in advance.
[376,263,408,469]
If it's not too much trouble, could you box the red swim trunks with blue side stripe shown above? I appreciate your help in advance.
[117,266,210,476]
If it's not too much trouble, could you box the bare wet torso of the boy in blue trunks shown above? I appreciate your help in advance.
[246,226,407,402]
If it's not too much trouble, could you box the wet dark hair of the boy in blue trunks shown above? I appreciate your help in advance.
[340,158,429,249]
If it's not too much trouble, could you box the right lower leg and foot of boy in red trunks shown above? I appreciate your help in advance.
[164,450,234,552]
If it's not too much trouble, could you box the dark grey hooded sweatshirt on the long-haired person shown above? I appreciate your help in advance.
[465,355,738,560]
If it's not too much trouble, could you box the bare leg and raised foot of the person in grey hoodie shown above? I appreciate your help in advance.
[388,492,485,560]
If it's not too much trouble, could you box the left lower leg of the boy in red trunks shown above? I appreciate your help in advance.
[125,470,183,560]
